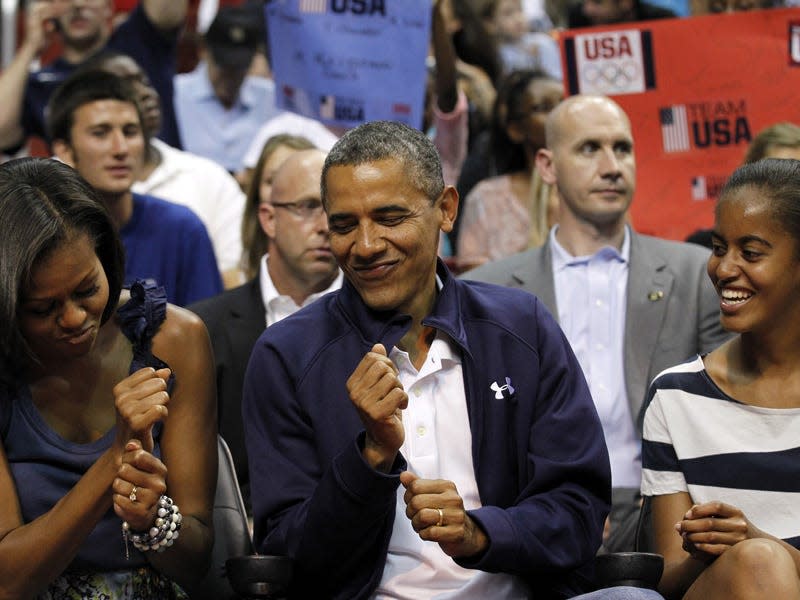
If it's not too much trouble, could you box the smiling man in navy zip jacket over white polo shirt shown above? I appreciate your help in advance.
[243,122,647,599]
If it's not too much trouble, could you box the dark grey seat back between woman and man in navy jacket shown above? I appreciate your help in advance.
[186,435,254,600]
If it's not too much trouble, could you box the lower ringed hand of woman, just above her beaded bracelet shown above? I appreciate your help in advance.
[111,439,167,531]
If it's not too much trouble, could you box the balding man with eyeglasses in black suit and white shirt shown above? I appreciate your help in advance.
[189,149,342,510]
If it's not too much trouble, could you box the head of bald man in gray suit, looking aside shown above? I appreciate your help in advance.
[537,96,636,229]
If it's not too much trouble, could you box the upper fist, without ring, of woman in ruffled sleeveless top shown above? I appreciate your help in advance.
[114,367,170,452]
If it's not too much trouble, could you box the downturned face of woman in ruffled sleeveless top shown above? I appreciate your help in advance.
[18,234,109,363]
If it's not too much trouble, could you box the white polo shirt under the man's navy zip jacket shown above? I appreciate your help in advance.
[373,332,528,600]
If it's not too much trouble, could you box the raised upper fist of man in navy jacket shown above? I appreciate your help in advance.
[347,344,408,472]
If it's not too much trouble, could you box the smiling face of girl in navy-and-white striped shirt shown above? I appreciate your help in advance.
[708,186,800,333]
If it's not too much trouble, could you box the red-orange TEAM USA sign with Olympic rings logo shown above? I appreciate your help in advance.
[561,8,800,240]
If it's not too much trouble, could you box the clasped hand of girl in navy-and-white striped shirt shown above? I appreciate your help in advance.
[675,501,767,563]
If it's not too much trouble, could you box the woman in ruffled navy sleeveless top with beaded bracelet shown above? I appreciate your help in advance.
[0,159,216,599]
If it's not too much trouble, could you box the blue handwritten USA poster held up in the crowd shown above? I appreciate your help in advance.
[265,0,431,128]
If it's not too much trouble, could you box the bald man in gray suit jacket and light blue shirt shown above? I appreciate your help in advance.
[464,96,727,551]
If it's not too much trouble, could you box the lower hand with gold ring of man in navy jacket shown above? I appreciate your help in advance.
[400,471,489,558]
